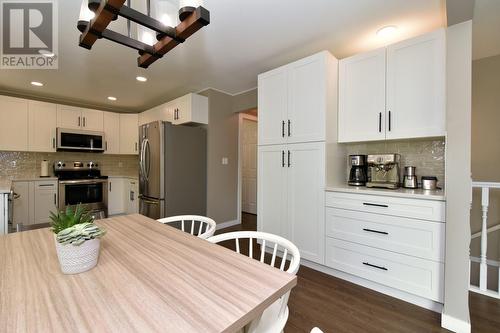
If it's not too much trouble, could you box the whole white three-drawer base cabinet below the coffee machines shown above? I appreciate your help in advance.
[325,191,445,303]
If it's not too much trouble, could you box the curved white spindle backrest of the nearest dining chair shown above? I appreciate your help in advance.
[208,231,300,274]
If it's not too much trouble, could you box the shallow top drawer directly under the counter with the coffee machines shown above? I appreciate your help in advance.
[325,192,445,222]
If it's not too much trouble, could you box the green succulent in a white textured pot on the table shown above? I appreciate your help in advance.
[50,205,106,274]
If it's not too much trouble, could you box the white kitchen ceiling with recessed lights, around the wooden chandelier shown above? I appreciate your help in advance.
[0,0,446,112]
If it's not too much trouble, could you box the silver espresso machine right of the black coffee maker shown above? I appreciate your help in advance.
[366,154,401,189]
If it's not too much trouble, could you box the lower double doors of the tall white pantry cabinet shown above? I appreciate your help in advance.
[257,143,325,264]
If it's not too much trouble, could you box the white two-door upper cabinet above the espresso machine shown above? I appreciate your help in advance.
[338,29,446,142]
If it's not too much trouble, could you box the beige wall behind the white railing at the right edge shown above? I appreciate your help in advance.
[471,55,500,290]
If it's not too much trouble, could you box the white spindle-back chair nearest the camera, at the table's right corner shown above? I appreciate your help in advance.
[208,231,300,333]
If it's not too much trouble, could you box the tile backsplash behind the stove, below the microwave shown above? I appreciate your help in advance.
[0,151,139,180]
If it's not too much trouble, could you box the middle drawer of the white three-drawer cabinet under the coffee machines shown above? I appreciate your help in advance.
[326,207,445,262]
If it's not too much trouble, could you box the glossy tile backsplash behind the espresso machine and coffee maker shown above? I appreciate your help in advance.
[345,139,445,186]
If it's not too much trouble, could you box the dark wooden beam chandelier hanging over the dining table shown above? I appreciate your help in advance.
[77,0,210,68]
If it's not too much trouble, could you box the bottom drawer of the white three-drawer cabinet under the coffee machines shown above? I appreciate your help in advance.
[326,237,444,303]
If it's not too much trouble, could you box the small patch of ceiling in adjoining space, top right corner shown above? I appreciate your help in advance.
[472,0,500,60]
